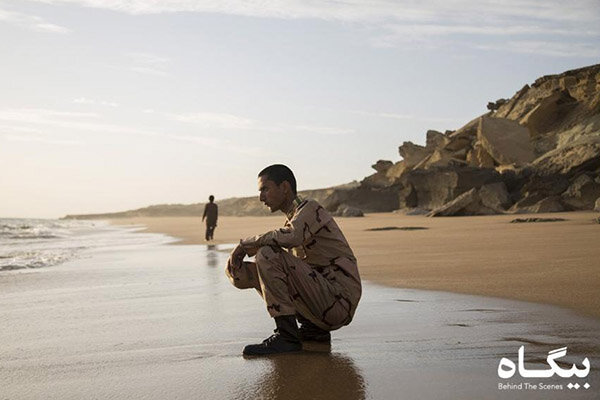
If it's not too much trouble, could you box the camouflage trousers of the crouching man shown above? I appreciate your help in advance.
[225,246,356,330]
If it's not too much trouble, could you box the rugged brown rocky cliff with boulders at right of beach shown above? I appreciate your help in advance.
[358,65,600,215]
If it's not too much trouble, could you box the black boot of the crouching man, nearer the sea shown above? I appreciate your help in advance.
[244,315,302,356]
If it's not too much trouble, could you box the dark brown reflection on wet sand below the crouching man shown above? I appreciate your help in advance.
[237,351,366,400]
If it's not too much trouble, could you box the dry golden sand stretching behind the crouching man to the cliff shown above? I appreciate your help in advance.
[111,212,600,318]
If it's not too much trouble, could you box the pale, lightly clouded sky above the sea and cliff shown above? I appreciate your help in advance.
[0,0,600,218]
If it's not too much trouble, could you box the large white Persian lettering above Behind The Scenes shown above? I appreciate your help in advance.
[498,346,590,389]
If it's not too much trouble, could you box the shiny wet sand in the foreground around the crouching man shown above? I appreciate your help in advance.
[0,241,600,399]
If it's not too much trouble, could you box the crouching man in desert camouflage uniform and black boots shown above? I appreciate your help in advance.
[225,164,362,355]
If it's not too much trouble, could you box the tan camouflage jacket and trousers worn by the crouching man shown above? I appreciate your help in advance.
[226,197,362,330]
